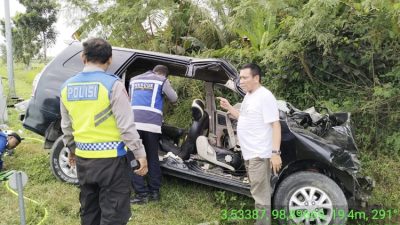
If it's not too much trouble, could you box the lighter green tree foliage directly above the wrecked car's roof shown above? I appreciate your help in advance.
[64,0,236,54]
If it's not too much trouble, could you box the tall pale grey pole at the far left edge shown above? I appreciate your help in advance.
[4,0,17,99]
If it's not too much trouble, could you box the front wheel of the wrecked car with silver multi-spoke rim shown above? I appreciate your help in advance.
[272,172,348,225]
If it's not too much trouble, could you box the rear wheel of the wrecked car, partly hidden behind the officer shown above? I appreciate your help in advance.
[50,136,78,184]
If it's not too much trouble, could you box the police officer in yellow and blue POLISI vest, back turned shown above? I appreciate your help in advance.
[60,38,147,225]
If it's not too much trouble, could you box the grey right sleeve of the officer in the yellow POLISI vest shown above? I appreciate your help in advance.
[110,81,146,159]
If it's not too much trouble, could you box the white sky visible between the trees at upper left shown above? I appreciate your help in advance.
[0,0,76,56]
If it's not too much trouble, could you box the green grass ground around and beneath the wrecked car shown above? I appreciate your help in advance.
[0,64,400,225]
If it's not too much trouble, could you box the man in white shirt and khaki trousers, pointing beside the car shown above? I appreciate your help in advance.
[219,63,282,225]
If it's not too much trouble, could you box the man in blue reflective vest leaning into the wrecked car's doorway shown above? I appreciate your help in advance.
[129,65,178,204]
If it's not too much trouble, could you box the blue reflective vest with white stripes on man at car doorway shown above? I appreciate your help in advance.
[129,71,167,133]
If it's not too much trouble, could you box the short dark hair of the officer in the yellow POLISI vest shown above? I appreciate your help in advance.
[82,38,112,64]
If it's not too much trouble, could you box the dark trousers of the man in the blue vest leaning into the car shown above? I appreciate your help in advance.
[132,130,162,194]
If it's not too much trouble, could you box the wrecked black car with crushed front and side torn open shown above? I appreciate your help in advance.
[23,42,373,224]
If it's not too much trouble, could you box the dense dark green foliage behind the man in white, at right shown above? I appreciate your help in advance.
[205,0,400,155]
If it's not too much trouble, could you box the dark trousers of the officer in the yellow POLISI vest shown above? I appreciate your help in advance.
[76,156,131,225]
